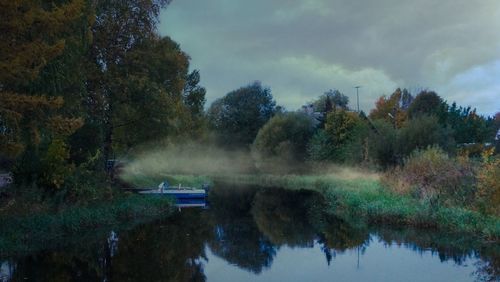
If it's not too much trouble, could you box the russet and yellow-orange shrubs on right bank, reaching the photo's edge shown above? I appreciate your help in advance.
[382,147,500,218]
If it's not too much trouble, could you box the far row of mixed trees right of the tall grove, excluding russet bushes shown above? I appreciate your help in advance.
[207,82,500,169]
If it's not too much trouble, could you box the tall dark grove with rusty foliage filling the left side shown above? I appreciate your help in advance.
[0,0,205,197]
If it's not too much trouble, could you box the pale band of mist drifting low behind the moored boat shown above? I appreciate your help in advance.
[123,142,379,180]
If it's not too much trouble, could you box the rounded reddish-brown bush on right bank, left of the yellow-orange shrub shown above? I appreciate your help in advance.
[384,146,476,205]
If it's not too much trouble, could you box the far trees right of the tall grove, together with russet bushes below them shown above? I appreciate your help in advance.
[208,83,500,216]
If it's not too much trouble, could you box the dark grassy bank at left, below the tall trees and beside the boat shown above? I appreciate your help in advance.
[0,195,174,257]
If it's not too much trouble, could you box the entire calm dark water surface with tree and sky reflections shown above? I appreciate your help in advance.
[0,185,500,282]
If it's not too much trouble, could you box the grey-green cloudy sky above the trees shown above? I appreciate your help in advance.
[159,0,500,115]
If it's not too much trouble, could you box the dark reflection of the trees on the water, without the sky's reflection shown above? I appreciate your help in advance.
[0,184,500,282]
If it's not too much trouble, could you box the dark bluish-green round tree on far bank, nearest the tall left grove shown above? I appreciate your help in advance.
[208,81,276,147]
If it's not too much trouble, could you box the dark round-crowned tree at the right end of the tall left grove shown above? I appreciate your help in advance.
[111,37,205,151]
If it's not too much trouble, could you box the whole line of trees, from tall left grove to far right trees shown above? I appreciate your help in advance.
[0,0,500,209]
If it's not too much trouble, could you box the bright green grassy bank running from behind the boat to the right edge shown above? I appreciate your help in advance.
[127,174,500,242]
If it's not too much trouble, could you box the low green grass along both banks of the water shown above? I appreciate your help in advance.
[0,167,500,256]
